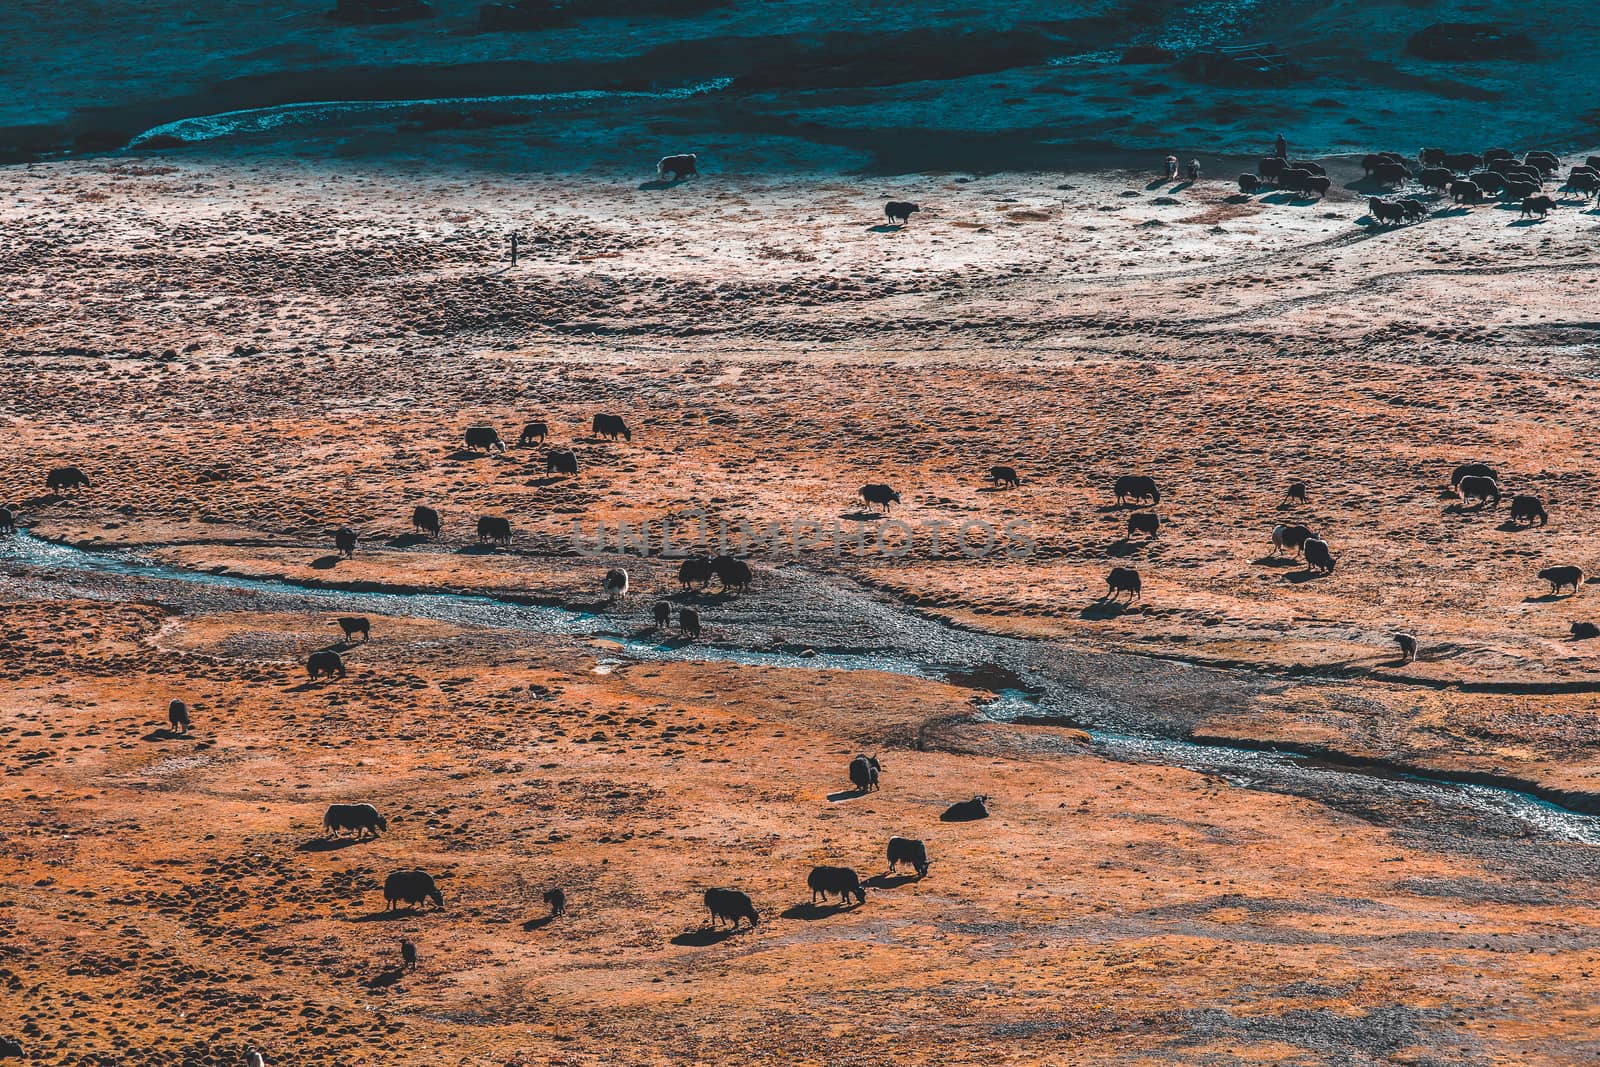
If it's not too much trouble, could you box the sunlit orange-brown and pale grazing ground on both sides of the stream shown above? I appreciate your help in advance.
[0,155,1600,1064]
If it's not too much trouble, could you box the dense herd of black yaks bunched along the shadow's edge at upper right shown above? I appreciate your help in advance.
[1238,149,1600,226]
